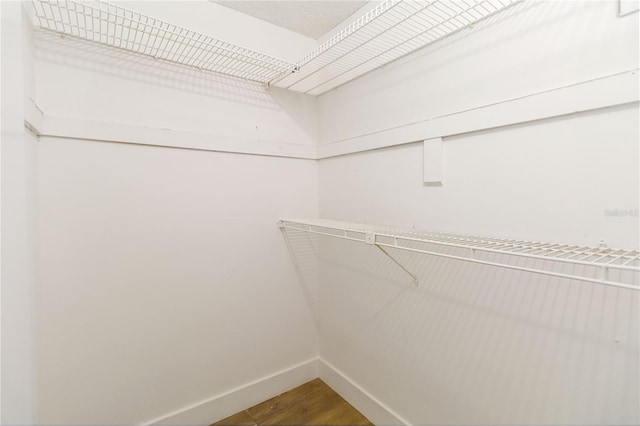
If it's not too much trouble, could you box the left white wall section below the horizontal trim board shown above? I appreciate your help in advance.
[37,138,317,424]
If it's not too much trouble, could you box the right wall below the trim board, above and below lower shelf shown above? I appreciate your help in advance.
[318,99,640,425]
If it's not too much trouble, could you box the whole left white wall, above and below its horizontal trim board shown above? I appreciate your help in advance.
[30,2,317,424]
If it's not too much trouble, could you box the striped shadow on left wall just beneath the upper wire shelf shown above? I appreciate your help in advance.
[33,28,280,110]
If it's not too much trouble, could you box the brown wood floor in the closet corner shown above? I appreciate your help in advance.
[212,379,373,426]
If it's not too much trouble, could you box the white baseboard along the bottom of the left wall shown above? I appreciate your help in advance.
[145,358,318,426]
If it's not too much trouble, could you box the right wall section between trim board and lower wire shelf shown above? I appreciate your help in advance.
[320,104,640,248]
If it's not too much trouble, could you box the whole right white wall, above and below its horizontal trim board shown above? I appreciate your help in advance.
[316,2,640,425]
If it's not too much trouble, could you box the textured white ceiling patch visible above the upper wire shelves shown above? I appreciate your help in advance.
[215,0,367,40]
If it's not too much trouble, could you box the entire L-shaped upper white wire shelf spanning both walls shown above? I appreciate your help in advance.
[32,0,522,95]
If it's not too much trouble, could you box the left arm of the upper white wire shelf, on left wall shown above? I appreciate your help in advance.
[32,0,296,84]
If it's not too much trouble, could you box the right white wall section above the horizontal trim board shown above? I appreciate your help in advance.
[318,1,640,144]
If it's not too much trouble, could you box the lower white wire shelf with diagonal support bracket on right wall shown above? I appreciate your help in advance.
[278,219,640,291]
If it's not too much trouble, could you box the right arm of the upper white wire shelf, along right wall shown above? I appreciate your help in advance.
[271,0,521,95]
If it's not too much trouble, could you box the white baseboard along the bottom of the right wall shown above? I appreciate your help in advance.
[318,358,411,425]
